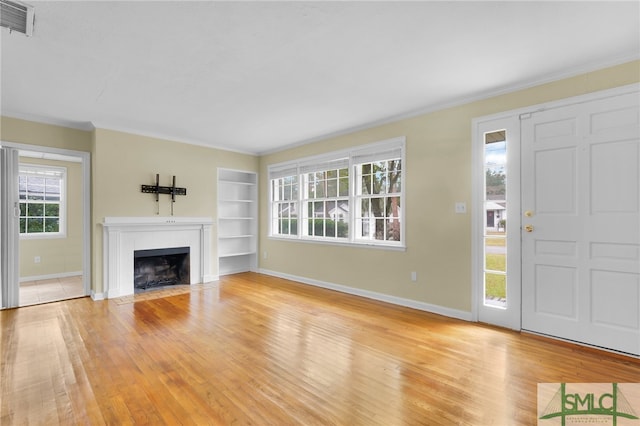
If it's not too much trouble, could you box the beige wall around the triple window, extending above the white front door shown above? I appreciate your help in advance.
[260,61,640,312]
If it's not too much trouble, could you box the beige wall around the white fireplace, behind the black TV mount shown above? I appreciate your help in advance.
[92,129,258,293]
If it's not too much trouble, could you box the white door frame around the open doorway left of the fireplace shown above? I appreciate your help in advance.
[0,141,91,308]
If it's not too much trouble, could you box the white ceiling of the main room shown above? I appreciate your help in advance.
[0,1,640,154]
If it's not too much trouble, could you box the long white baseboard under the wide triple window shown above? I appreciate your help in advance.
[258,269,472,321]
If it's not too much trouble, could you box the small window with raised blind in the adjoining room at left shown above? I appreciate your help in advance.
[18,164,66,237]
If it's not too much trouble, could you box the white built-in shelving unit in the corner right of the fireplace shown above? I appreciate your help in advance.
[218,168,258,275]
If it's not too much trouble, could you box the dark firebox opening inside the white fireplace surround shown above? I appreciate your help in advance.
[133,247,190,293]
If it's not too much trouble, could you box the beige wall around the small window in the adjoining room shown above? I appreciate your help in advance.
[20,157,82,279]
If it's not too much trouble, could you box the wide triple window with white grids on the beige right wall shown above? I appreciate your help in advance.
[269,138,405,246]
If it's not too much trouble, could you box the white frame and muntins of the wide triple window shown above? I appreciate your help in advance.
[267,136,406,250]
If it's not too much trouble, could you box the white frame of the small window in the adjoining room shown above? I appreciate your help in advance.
[18,163,68,240]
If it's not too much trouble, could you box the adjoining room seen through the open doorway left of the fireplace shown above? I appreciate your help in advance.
[18,150,85,306]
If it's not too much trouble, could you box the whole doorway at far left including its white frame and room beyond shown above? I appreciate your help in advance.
[0,142,90,308]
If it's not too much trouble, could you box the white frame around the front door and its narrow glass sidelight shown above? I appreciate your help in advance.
[471,83,640,330]
